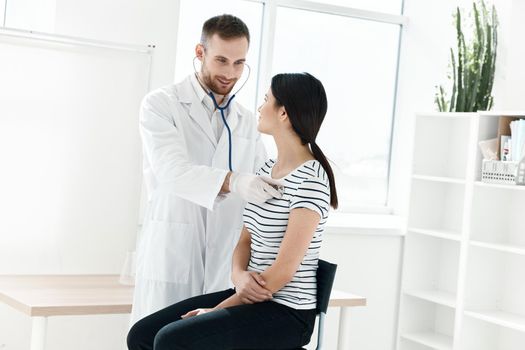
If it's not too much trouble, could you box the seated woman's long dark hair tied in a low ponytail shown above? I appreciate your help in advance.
[271,73,338,209]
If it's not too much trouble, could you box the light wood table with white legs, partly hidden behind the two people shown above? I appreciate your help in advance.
[0,275,366,350]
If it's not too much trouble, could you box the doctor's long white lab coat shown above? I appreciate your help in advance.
[131,77,266,324]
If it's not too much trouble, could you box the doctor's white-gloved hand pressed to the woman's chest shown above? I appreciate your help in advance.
[229,173,282,204]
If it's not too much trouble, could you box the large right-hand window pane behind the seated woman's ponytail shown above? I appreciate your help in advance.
[272,7,399,210]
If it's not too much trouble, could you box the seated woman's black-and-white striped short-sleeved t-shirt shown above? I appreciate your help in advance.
[243,159,330,310]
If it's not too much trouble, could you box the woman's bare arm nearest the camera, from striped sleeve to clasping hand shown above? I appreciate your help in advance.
[261,208,321,293]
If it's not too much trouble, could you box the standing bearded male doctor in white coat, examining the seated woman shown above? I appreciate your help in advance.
[131,15,280,324]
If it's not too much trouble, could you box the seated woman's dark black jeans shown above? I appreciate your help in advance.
[127,289,315,350]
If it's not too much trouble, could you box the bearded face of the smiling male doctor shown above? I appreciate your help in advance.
[195,34,248,95]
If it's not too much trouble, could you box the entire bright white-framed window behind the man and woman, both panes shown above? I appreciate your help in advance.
[175,0,405,212]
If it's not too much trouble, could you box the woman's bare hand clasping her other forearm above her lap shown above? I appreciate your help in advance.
[233,271,272,304]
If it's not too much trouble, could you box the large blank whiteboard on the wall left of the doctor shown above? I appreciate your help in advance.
[0,36,151,273]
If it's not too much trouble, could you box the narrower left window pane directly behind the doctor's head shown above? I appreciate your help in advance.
[175,0,263,110]
